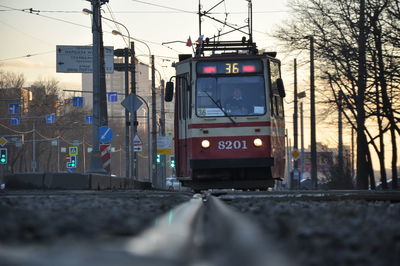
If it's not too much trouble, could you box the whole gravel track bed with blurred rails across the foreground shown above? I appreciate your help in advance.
[0,191,400,266]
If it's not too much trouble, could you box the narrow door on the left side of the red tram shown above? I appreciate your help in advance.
[175,73,191,177]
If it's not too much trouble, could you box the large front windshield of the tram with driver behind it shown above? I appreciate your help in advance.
[196,75,266,117]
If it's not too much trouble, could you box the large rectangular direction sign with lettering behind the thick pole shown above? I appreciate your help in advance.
[56,45,114,73]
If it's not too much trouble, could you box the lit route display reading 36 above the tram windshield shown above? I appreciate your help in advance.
[197,60,262,75]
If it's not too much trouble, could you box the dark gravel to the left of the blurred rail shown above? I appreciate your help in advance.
[0,191,192,245]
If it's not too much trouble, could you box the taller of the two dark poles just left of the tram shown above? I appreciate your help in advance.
[149,55,159,188]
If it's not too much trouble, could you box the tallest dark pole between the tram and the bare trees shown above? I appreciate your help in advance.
[309,35,318,189]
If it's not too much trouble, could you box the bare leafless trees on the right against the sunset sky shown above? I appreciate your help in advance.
[275,0,400,189]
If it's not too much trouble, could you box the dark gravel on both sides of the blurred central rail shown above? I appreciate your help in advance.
[0,191,400,266]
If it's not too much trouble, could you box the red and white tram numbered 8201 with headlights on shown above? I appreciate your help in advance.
[166,42,285,190]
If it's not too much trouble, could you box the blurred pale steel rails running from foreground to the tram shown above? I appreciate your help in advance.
[126,194,293,266]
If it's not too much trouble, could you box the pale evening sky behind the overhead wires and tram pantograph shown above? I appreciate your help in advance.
[0,0,376,163]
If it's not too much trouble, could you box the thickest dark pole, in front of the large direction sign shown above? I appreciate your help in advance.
[89,0,108,173]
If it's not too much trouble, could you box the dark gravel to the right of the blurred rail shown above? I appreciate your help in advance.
[226,195,400,266]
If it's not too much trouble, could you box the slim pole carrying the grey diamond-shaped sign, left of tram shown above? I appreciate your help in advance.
[130,41,138,180]
